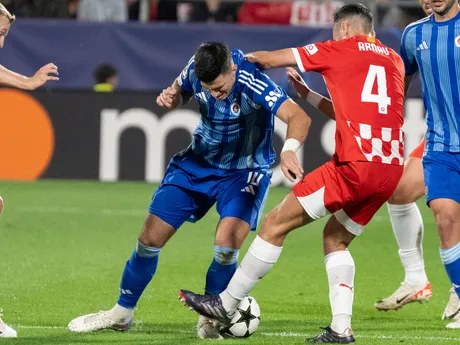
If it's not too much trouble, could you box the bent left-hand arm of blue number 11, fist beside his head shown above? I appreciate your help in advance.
[157,56,194,110]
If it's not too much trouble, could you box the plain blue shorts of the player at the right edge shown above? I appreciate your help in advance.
[423,151,460,205]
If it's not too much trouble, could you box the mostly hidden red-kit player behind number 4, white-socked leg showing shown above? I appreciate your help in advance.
[288,0,444,319]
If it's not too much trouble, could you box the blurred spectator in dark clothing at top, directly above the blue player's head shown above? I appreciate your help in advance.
[190,0,241,23]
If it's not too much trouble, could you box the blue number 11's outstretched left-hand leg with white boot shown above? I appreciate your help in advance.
[69,185,202,332]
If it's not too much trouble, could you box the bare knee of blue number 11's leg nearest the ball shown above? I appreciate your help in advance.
[214,217,251,249]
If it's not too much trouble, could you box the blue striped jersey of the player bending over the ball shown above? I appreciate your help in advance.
[177,50,288,170]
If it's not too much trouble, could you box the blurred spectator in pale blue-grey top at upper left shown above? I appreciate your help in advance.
[77,0,128,22]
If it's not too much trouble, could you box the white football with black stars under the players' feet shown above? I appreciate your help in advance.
[220,296,260,338]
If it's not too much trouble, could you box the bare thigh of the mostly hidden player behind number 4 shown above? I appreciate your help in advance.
[388,157,425,205]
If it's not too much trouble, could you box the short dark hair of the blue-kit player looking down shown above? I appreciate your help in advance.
[195,42,232,83]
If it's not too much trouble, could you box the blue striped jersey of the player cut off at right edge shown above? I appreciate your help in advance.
[401,13,460,152]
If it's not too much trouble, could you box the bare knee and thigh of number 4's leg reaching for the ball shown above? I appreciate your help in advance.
[259,191,314,246]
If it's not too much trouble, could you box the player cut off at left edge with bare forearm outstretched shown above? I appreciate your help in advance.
[0,4,59,338]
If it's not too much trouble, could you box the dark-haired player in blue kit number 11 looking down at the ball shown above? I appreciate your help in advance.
[69,43,311,338]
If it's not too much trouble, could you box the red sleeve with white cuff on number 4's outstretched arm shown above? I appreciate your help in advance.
[292,41,332,72]
